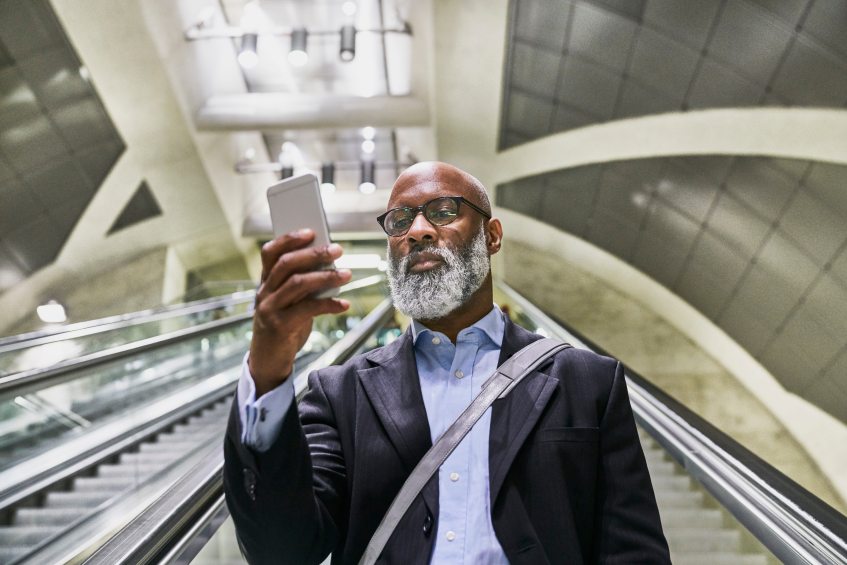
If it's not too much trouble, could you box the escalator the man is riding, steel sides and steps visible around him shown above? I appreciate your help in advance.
[79,285,847,565]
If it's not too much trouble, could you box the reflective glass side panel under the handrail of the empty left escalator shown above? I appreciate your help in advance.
[0,279,385,472]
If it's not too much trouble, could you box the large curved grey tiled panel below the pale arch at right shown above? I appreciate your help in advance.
[497,156,847,424]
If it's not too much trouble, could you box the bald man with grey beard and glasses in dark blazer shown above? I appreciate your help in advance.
[225,163,670,565]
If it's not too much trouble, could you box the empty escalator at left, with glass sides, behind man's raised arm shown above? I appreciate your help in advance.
[0,277,399,564]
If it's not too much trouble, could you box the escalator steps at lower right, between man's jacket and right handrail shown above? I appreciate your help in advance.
[638,429,774,565]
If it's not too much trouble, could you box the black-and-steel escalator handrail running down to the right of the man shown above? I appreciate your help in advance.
[499,282,847,563]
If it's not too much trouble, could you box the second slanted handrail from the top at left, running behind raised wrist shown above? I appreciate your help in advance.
[0,275,384,398]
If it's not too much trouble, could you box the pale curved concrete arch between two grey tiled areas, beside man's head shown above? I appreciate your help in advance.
[487,108,847,186]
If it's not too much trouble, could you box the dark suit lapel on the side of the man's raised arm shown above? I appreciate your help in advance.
[358,330,438,510]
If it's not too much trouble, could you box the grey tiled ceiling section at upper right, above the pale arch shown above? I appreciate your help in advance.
[499,0,847,149]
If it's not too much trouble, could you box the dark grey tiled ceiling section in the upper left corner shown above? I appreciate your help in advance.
[0,0,125,293]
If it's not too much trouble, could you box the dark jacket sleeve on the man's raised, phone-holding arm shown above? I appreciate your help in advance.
[224,373,347,565]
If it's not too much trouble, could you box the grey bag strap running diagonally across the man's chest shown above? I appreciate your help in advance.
[359,338,571,565]
